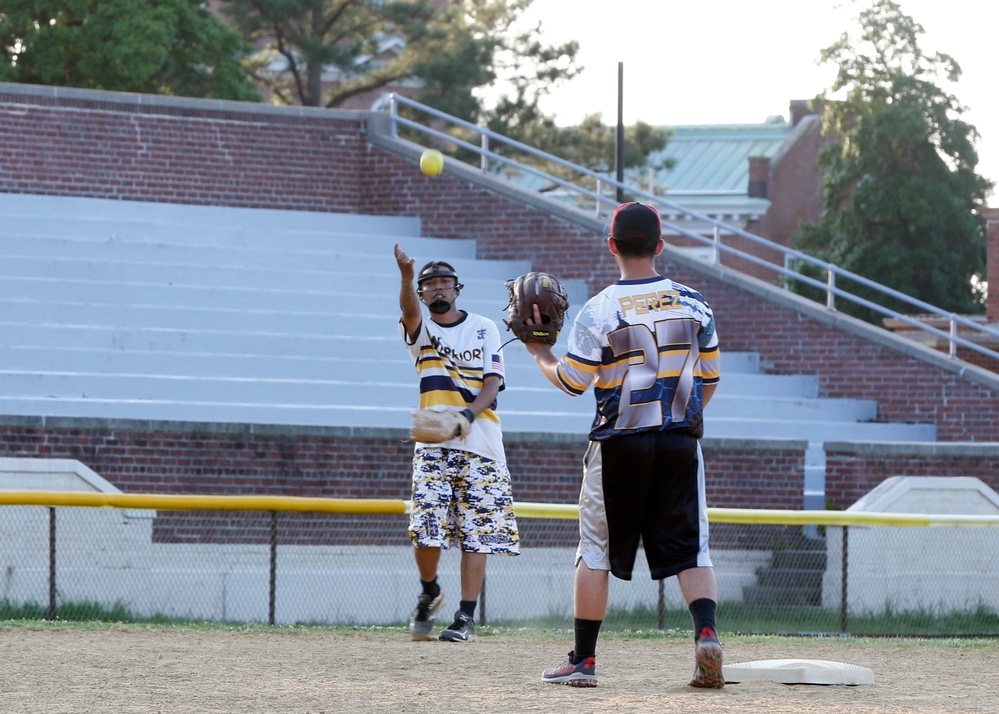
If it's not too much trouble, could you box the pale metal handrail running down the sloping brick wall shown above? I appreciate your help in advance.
[388,94,999,360]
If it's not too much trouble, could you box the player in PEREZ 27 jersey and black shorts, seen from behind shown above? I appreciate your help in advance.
[525,202,724,688]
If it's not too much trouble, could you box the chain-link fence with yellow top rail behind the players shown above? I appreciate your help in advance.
[0,493,999,636]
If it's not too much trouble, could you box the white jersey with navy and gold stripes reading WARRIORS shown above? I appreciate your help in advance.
[399,311,506,463]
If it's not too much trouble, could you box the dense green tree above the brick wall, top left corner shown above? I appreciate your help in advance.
[0,0,260,101]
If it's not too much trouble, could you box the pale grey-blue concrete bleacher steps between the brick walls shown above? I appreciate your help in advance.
[0,194,935,442]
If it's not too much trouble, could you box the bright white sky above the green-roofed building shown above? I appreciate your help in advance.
[522,0,999,192]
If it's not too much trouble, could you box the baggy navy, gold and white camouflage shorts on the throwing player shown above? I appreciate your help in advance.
[409,447,520,555]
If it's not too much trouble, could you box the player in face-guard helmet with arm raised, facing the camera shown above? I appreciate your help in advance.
[395,244,520,642]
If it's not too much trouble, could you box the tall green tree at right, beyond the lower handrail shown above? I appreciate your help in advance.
[795,0,992,321]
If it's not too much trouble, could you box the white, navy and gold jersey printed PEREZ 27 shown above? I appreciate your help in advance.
[558,276,721,441]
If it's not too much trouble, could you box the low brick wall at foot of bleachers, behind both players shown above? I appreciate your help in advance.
[0,417,805,545]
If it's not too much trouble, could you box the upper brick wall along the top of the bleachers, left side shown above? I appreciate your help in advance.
[0,84,366,211]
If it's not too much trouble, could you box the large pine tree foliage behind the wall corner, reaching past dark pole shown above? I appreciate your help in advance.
[222,0,668,184]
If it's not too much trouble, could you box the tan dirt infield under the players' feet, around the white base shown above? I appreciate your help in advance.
[0,626,999,714]
